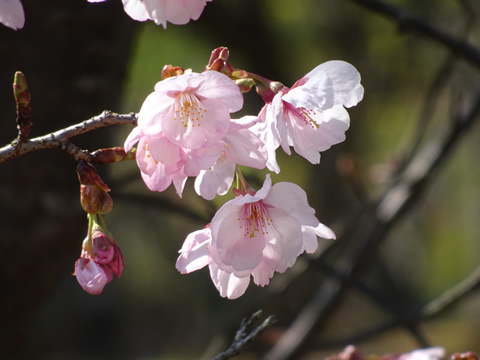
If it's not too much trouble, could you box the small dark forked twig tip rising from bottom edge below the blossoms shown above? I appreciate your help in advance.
[213,310,275,360]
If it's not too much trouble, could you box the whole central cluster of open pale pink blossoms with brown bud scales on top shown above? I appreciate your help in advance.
[125,48,363,299]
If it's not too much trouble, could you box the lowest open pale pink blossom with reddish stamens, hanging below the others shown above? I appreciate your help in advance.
[176,175,335,299]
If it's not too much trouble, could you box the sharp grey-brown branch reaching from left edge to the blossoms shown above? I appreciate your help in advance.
[0,110,137,164]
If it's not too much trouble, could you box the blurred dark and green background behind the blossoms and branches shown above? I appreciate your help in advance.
[0,0,480,360]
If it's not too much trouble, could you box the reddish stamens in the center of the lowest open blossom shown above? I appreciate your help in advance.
[238,200,273,238]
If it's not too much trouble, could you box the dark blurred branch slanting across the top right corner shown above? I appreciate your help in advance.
[350,0,480,67]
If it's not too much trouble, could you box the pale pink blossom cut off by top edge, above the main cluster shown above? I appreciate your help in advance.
[87,0,212,28]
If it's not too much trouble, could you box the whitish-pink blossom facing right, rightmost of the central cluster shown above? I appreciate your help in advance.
[252,61,363,173]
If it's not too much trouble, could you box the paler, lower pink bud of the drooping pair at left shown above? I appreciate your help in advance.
[74,257,109,295]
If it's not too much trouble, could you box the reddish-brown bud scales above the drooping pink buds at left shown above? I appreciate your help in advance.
[77,162,113,214]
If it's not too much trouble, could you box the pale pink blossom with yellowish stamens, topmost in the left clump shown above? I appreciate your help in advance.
[138,71,243,149]
